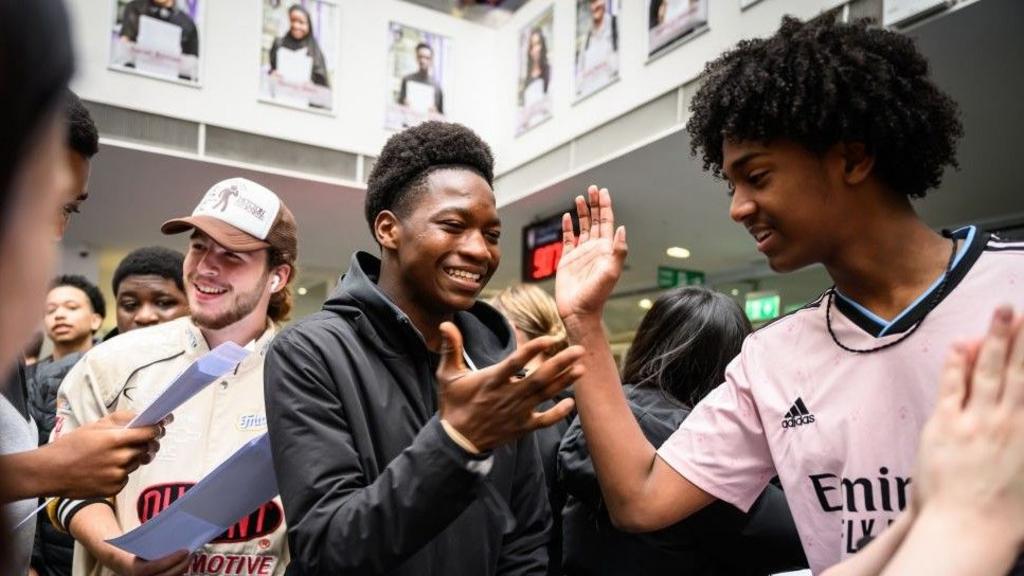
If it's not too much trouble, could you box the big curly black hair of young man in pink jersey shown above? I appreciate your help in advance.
[686,15,964,198]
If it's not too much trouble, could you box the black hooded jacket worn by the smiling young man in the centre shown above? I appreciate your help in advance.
[264,252,551,576]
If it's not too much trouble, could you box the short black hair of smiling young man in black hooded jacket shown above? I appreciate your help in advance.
[366,122,495,239]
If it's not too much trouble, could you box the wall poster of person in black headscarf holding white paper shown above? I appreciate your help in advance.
[259,0,339,112]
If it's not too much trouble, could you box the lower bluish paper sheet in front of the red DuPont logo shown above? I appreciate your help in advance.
[108,434,278,560]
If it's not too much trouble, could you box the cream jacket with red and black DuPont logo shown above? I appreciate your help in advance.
[50,318,289,576]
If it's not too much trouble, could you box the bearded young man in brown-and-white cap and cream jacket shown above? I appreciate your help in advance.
[51,178,297,576]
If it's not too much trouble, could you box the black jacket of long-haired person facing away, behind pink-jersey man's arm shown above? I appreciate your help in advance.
[558,386,807,576]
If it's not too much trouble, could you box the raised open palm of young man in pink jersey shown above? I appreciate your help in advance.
[555,186,627,329]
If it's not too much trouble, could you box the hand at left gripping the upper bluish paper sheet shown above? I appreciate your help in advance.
[46,411,170,498]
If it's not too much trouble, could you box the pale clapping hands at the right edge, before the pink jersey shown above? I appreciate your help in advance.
[913,307,1024,545]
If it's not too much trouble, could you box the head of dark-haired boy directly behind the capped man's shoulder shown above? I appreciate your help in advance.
[103,246,188,341]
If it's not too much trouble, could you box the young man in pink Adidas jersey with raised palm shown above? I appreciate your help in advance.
[556,14,1024,572]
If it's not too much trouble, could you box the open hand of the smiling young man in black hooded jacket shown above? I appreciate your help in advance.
[437,322,584,451]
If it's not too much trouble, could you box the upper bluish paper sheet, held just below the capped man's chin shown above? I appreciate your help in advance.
[128,342,249,428]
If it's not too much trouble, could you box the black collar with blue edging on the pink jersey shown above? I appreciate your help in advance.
[835,227,989,338]
